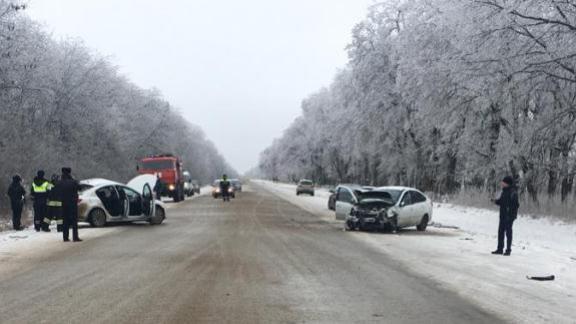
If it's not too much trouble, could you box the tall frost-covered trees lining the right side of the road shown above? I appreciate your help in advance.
[259,0,576,208]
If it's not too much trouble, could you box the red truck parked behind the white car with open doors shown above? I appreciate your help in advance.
[138,154,185,202]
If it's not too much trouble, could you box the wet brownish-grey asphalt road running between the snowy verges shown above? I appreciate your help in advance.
[0,185,501,324]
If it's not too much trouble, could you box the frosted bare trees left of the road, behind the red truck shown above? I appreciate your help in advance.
[0,0,233,205]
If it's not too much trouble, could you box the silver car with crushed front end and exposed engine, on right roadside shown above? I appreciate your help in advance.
[336,187,432,231]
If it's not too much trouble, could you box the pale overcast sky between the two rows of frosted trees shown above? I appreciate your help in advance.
[27,0,372,172]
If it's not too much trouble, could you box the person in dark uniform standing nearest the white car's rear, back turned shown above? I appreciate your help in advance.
[56,168,82,242]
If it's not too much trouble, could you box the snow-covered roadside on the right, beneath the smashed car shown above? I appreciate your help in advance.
[255,181,576,323]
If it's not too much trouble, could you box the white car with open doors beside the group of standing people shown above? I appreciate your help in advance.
[78,175,166,227]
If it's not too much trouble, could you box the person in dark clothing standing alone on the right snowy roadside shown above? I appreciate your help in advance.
[492,176,520,255]
